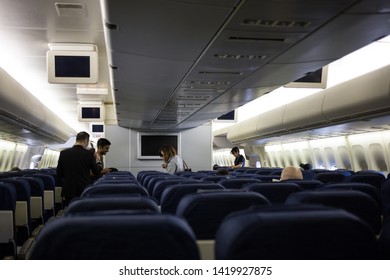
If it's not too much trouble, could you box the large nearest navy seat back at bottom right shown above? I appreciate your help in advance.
[215,205,377,260]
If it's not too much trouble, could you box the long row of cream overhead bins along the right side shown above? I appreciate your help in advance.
[227,65,390,144]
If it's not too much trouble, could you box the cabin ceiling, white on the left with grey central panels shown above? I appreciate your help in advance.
[0,0,390,140]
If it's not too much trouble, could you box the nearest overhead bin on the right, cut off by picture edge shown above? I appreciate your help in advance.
[322,66,390,123]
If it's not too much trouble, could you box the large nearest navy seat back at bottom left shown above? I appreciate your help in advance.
[28,214,199,260]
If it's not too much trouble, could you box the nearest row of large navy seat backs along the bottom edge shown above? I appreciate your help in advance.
[21,201,390,260]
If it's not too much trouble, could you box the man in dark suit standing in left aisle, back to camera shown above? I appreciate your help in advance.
[57,131,102,206]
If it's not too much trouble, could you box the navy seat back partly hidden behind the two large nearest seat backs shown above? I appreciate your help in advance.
[176,191,270,239]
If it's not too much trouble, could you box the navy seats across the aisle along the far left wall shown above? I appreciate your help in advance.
[0,172,55,258]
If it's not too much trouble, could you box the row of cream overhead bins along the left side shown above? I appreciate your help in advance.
[0,68,75,145]
